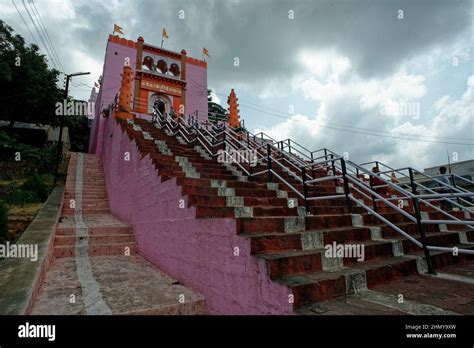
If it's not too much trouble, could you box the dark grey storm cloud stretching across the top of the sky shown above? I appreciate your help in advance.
[61,0,471,86]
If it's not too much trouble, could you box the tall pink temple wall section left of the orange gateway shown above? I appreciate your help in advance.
[89,41,137,154]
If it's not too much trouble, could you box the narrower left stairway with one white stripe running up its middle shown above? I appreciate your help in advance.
[29,153,207,315]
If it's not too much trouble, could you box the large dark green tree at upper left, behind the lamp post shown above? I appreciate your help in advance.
[0,20,62,127]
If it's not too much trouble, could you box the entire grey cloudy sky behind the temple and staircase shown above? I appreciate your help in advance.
[0,0,474,169]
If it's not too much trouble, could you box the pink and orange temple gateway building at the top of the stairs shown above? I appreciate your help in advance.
[89,35,208,150]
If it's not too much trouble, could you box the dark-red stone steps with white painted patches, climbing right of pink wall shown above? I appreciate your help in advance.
[118,118,473,312]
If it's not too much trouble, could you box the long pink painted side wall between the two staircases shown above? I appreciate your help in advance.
[102,119,293,314]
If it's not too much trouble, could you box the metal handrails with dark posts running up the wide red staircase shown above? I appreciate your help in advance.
[145,106,474,273]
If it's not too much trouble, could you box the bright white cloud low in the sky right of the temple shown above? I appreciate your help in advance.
[254,49,474,168]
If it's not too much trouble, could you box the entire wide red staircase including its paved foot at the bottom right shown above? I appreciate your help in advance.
[119,118,474,314]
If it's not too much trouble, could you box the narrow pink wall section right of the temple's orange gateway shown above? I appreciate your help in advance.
[185,63,207,121]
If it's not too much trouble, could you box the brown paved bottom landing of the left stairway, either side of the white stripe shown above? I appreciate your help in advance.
[31,255,207,315]
